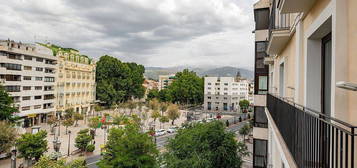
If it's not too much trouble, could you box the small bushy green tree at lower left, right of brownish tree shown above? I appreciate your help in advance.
[16,131,47,161]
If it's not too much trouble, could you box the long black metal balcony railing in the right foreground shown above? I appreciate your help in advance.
[267,94,357,168]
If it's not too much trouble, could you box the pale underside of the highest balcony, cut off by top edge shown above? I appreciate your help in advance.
[278,0,316,13]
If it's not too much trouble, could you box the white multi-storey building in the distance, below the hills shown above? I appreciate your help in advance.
[203,77,249,112]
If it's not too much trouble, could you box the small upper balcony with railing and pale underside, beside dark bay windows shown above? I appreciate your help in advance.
[267,0,294,55]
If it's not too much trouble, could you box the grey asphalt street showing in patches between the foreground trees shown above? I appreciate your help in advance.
[86,121,248,168]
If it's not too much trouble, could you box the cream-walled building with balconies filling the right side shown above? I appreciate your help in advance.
[253,0,357,168]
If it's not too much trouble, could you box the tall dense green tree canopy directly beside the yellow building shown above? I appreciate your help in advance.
[96,55,145,106]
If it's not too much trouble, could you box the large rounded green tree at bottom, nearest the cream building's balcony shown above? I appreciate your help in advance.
[161,121,243,168]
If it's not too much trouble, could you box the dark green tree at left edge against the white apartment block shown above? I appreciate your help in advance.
[0,85,18,122]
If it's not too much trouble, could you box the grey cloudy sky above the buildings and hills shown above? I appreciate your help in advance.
[0,0,256,69]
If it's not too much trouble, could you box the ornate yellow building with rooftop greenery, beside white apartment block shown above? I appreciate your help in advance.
[47,45,96,117]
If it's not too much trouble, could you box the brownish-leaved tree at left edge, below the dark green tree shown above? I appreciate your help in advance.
[0,121,17,153]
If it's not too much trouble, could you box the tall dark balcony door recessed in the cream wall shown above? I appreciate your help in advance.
[321,33,332,116]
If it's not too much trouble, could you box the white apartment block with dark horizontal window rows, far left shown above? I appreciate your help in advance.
[0,40,57,127]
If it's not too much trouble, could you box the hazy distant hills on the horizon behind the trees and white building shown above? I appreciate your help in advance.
[144,66,254,80]
